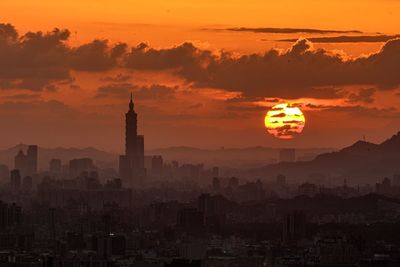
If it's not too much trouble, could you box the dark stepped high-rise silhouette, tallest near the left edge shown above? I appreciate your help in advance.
[14,145,38,176]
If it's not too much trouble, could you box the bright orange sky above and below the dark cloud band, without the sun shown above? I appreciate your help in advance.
[0,0,400,151]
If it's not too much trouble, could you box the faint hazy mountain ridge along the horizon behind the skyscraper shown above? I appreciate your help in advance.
[0,144,334,170]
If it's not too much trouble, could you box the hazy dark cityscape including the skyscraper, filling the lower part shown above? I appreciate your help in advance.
[0,96,400,266]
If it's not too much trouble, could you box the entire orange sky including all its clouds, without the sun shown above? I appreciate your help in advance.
[0,0,400,153]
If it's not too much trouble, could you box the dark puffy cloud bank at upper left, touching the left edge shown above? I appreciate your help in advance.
[0,24,126,91]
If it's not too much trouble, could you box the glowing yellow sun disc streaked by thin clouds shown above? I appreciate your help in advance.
[264,103,306,139]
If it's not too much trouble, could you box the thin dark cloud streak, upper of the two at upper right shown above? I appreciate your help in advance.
[225,27,362,34]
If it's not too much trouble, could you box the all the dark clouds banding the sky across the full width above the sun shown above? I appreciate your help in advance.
[0,24,400,101]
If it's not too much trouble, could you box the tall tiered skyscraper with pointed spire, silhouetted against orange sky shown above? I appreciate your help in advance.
[119,94,146,186]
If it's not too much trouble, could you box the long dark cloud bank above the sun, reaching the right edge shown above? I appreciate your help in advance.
[127,39,400,99]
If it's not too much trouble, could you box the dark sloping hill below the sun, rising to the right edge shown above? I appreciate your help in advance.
[252,132,400,184]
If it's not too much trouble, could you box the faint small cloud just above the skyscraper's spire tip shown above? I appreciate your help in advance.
[96,83,178,100]
